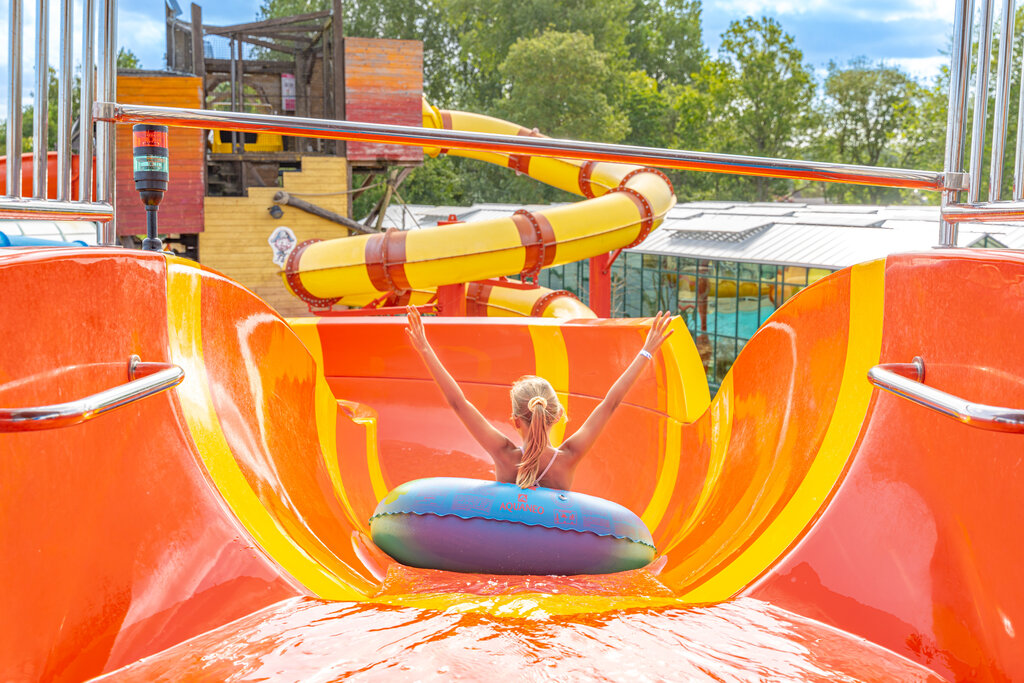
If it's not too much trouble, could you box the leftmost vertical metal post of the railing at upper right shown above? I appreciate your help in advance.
[939,0,974,247]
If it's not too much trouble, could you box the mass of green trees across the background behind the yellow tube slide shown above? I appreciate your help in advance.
[253,0,950,208]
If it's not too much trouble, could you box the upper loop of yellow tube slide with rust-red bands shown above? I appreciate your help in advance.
[283,102,676,314]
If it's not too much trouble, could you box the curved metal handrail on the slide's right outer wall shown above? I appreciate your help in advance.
[867,356,1024,434]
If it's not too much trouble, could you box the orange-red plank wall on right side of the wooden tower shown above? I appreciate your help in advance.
[345,38,423,163]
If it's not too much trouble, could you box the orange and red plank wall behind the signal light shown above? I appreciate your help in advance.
[115,73,207,234]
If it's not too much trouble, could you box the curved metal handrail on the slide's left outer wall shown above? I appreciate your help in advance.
[0,355,185,432]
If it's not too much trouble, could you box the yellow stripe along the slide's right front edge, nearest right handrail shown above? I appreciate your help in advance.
[683,260,885,602]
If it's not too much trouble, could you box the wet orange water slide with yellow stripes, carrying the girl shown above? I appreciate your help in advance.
[0,242,1024,681]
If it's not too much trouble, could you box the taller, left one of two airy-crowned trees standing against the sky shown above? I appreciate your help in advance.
[703,16,815,201]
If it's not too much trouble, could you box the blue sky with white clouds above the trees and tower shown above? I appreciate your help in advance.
[0,0,953,118]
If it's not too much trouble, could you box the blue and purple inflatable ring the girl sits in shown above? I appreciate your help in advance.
[370,477,655,575]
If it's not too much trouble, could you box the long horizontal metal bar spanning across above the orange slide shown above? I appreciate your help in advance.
[93,101,966,191]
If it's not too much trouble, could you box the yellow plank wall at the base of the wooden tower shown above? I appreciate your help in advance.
[199,157,348,315]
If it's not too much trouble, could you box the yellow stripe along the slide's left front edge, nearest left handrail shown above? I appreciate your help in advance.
[167,259,366,600]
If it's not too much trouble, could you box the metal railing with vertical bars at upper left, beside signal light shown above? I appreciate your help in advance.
[0,0,117,237]
